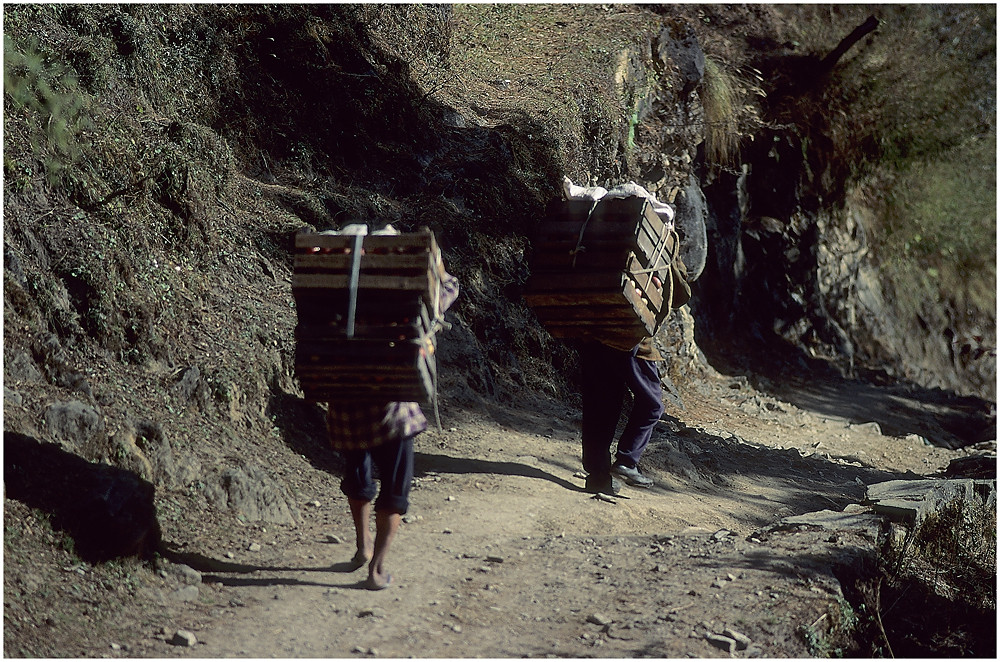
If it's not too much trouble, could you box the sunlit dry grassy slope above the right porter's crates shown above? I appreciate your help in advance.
[411,4,657,184]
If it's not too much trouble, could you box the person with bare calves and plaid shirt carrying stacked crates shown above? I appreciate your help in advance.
[326,226,459,590]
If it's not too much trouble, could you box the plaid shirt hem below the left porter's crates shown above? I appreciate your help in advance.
[326,402,427,451]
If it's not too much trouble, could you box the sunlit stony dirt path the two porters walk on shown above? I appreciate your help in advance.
[137,368,964,658]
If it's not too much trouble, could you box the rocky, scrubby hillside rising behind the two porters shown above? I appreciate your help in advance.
[4,4,996,660]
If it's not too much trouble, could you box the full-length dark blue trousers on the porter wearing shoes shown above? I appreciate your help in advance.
[580,342,663,479]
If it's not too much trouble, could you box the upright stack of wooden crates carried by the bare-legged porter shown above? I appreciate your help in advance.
[292,230,444,403]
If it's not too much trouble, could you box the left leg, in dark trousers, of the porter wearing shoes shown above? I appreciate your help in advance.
[579,342,627,485]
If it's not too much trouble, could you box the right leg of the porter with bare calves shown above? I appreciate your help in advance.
[367,437,413,590]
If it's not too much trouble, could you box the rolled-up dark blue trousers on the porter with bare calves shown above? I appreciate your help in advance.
[340,437,413,515]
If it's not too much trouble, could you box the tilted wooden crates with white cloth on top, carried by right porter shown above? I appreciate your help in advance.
[524,197,676,346]
